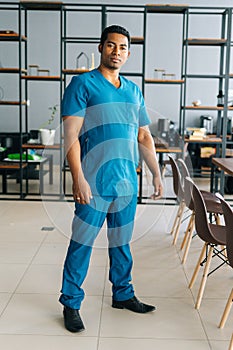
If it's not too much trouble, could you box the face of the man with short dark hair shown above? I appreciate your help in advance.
[99,33,130,70]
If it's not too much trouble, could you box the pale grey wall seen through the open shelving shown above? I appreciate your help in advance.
[0,0,233,137]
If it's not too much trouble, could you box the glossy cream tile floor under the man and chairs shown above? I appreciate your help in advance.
[0,191,233,350]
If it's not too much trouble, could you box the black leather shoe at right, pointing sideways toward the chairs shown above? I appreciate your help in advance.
[112,296,155,314]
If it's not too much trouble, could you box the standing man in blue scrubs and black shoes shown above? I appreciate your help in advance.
[59,25,163,332]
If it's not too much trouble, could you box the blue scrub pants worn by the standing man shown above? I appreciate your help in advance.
[59,195,137,309]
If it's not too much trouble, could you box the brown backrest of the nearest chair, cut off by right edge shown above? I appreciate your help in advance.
[216,193,233,267]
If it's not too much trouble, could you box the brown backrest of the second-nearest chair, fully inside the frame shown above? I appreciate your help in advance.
[185,177,215,243]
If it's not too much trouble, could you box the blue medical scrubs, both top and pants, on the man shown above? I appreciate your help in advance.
[60,69,150,309]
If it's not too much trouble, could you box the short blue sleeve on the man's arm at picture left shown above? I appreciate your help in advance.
[61,76,87,117]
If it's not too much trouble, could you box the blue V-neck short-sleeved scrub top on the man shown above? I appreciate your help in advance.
[62,69,150,196]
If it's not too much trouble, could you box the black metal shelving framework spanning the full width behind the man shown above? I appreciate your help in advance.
[0,1,233,204]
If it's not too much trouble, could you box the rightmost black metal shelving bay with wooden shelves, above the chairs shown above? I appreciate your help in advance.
[180,7,232,189]
